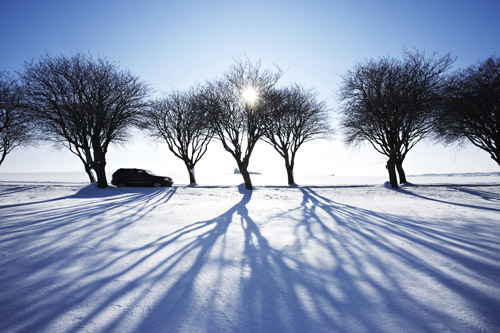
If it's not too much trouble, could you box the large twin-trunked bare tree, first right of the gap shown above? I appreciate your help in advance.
[340,51,454,188]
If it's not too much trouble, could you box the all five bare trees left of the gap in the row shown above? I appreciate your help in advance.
[0,54,329,189]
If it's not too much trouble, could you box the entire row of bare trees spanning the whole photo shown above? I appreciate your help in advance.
[0,51,500,189]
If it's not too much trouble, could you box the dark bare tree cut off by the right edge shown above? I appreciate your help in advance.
[436,57,500,165]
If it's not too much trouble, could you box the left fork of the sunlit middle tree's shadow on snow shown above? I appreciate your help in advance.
[129,187,252,332]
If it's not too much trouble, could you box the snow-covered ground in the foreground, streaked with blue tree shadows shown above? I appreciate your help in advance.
[0,184,500,332]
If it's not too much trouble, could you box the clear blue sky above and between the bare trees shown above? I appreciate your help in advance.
[0,0,500,176]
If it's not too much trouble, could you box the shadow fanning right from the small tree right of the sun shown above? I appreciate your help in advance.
[294,188,500,331]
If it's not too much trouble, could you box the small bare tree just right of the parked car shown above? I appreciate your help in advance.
[146,87,213,184]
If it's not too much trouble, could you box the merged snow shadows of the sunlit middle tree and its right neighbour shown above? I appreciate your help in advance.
[133,188,500,332]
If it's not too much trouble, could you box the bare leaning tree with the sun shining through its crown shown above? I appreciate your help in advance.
[201,60,283,190]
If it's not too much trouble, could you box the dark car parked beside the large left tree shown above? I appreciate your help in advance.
[111,169,174,187]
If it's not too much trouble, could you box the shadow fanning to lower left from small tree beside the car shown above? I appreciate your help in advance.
[0,184,177,332]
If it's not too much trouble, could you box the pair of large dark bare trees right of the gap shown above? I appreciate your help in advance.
[340,51,500,188]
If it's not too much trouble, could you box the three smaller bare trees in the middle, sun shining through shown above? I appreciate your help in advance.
[144,60,329,189]
